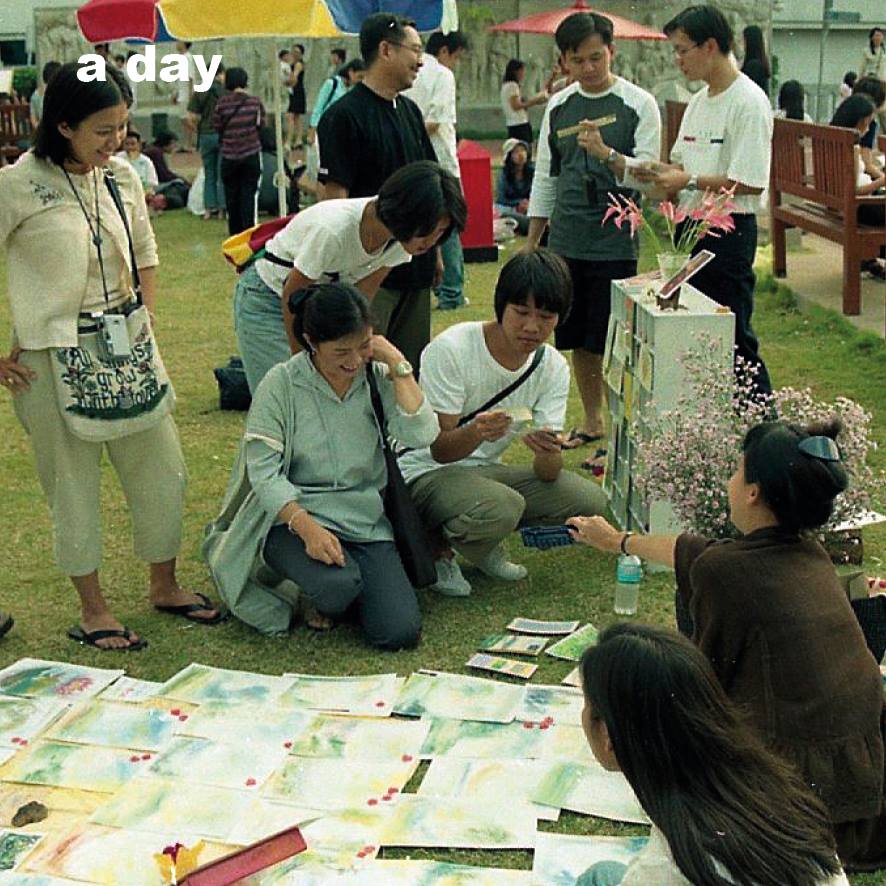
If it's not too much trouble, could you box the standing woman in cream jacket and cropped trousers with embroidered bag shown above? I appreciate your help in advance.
[0,62,222,650]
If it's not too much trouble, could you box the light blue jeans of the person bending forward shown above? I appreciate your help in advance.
[234,264,292,394]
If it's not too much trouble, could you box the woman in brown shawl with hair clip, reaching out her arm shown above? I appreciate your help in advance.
[568,422,886,871]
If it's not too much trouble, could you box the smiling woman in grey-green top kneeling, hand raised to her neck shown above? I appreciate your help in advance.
[204,282,439,649]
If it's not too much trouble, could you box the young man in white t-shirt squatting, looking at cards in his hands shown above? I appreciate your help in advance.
[400,249,606,597]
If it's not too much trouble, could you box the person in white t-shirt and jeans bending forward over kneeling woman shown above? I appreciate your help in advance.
[234,160,467,392]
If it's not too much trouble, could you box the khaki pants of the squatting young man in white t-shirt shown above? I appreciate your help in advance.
[409,464,606,563]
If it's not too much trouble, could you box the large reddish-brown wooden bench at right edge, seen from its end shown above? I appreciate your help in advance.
[769,119,886,314]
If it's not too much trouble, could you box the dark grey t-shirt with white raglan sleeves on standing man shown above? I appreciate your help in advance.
[529,77,661,261]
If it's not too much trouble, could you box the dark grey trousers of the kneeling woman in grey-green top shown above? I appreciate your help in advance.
[264,526,421,649]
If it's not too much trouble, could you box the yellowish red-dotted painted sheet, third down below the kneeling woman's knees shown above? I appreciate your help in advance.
[262,754,418,809]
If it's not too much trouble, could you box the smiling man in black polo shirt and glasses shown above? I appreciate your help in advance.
[317,12,445,368]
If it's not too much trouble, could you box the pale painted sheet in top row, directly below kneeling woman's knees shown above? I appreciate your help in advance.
[280,674,403,717]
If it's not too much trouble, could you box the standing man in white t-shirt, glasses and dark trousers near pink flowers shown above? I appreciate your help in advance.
[653,6,772,394]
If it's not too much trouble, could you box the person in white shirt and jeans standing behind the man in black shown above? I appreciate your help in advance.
[403,31,469,311]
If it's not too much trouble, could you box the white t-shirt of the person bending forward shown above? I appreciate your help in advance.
[256,197,412,295]
